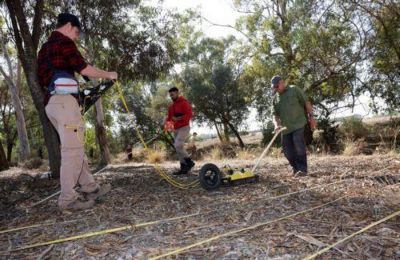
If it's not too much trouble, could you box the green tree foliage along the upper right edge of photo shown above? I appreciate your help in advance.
[358,1,400,113]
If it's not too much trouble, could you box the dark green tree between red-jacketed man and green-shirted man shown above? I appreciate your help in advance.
[179,37,251,145]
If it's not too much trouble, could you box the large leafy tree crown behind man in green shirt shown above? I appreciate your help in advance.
[235,0,364,123]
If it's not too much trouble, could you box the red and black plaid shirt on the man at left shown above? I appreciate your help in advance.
[38,31,87,105]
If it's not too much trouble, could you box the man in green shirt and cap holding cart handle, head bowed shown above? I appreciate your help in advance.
[271,76,316,176]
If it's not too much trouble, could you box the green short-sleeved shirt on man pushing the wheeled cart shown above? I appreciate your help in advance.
[272,86,308,135]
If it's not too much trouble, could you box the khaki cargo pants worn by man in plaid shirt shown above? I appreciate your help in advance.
[46,95,98,207]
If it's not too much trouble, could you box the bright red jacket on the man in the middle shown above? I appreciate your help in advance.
[167,96,193,129]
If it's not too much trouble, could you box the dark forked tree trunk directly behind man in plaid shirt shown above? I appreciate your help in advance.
[6,0,61,177]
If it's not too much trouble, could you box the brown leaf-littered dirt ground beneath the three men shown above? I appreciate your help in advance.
[0,155,400,259]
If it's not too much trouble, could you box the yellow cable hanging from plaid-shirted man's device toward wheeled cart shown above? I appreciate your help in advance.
[115,82,199,190]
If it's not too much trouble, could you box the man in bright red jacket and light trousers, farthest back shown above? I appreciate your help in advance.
[166,87,194,175]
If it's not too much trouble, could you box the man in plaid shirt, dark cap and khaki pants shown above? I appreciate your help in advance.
[38,13,118,210]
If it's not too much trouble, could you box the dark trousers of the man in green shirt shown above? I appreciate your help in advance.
[282,128,307,172]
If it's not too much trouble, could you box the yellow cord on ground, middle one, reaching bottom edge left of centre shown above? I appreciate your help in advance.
[150,195,347,260]
